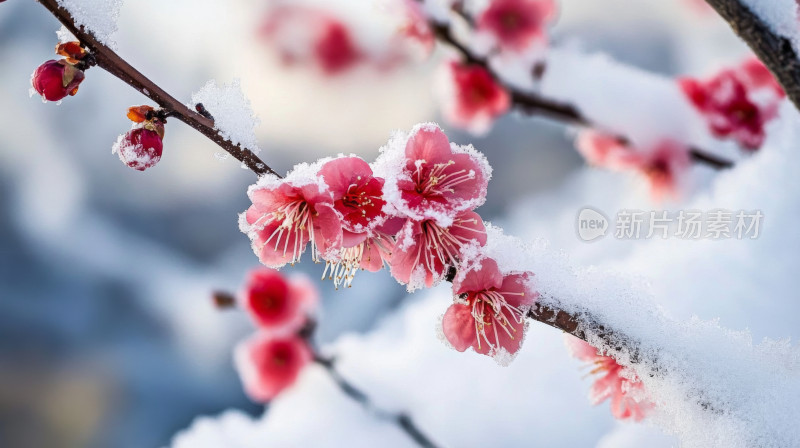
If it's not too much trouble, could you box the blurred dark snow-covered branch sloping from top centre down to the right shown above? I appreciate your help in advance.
[429,21,733,169]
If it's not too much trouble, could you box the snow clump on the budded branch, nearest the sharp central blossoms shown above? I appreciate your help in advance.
[188,79,261,154]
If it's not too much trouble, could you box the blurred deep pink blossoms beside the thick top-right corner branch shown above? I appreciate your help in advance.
[678,58,785,151]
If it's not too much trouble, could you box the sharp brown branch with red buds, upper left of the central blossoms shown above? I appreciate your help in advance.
[38,0,280,177]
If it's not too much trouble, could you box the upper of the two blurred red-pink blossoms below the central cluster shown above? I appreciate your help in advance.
[243,268,319,333]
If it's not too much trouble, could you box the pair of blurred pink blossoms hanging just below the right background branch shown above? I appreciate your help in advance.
[575,130,691,200]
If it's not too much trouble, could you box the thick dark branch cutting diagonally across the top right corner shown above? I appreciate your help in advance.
[706,0,800,114]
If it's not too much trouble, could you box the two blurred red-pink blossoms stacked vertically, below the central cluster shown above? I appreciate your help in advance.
[234,268,319,402]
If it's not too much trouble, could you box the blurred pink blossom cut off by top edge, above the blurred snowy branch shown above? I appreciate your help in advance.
[477,0,556,51]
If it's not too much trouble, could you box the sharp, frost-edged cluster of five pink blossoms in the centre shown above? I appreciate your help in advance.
[240,124,537,360]
